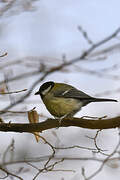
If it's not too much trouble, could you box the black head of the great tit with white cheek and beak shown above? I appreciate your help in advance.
[35,81,55,97]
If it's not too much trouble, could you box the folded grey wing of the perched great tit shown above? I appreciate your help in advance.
[54,88,93,101]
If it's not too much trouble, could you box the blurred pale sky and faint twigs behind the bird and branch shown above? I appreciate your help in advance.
[0,0,120,180]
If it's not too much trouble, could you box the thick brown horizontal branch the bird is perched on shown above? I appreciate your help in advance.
[0,116,120,133]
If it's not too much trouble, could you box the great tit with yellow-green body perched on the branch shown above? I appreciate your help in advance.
[35,81,117,118]
